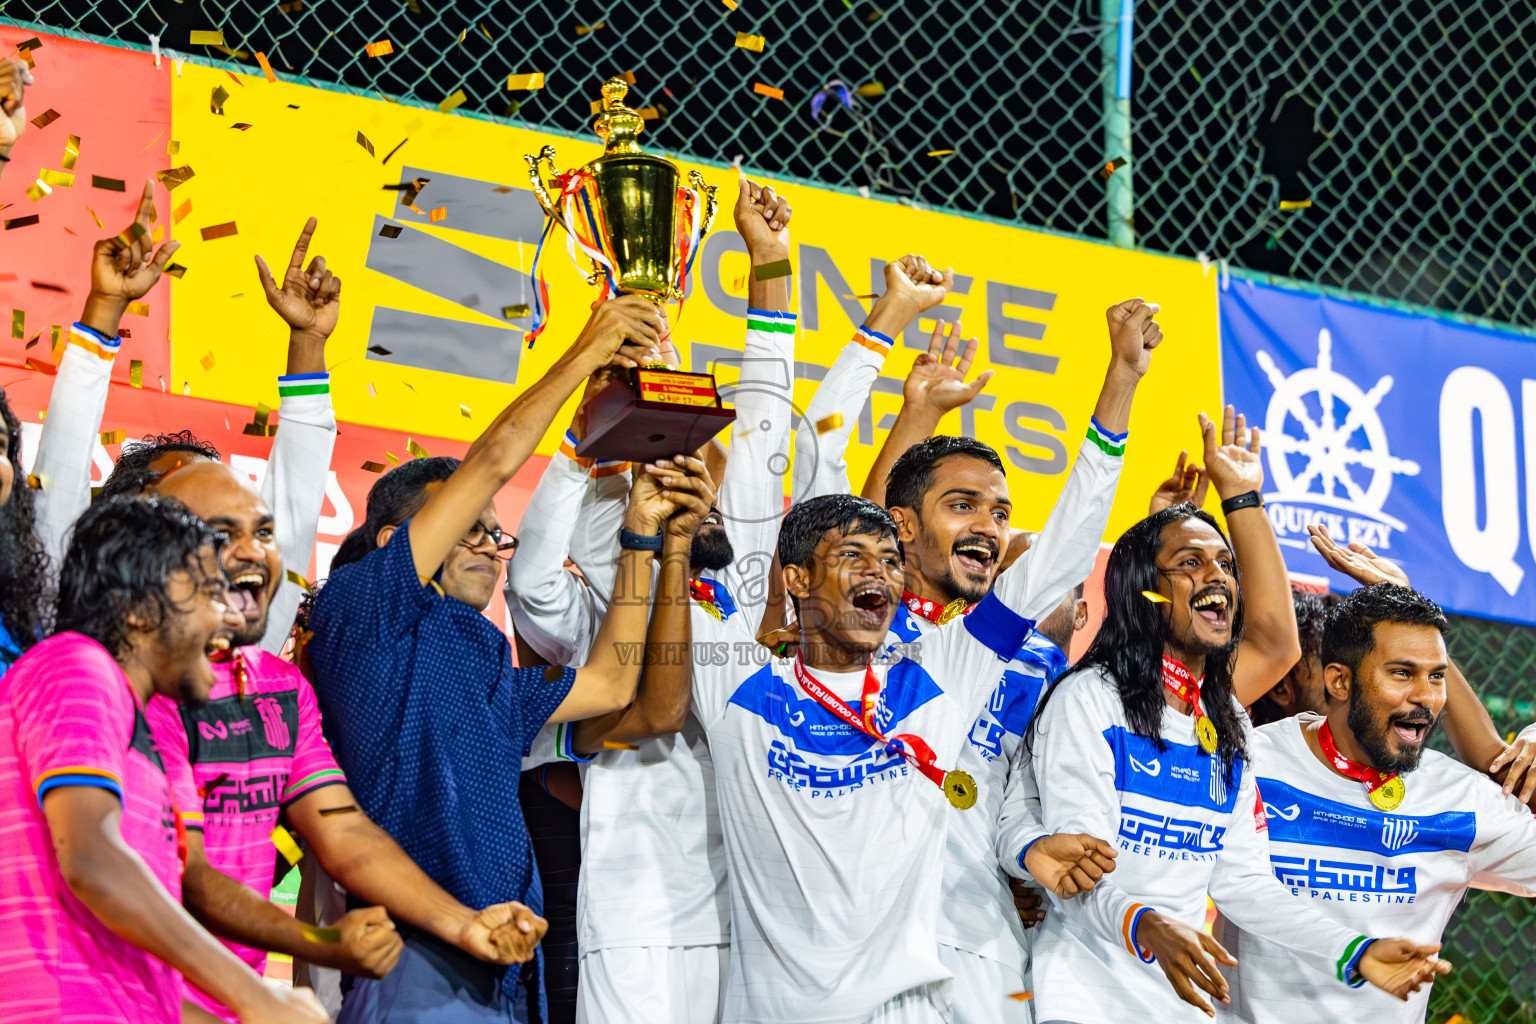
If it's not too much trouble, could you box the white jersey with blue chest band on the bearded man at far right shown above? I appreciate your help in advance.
[1218,714,1536,1024]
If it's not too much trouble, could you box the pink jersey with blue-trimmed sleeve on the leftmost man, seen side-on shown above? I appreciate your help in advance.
[0,633,181,1024]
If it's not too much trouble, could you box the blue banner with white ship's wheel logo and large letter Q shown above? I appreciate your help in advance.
[1220,278,1536,623]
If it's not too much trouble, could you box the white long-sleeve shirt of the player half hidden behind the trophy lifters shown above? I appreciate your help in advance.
[507,310,796,953]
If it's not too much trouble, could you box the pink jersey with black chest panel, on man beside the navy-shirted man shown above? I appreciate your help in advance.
[146,646,347,1021]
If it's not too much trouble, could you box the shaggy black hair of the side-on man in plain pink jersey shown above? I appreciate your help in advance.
[54,497,224,657]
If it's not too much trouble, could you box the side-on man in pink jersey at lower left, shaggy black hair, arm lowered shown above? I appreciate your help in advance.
[0,499,326,1024]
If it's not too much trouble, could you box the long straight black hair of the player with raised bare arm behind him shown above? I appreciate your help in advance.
[1028,502,1247,786]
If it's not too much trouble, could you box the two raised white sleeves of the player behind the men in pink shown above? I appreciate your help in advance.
[32,324,336,654]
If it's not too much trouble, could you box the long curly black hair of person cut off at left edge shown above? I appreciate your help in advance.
[0,388,52,659]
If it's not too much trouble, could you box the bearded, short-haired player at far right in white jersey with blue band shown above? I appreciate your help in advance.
[1221,582,1536,1024]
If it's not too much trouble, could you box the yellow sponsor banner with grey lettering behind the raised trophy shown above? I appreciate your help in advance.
[172,64,1220,536]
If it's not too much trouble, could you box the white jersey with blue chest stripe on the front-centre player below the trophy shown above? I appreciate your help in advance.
[693,603,1023,1024]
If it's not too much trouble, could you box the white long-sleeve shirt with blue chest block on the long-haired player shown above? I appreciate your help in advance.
[1032,669,1367,1024]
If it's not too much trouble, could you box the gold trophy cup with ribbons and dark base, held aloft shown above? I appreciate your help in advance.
[524,78,736,462]
